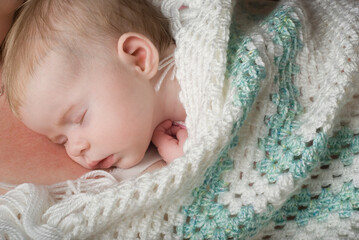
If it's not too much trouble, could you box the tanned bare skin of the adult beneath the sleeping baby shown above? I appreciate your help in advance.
[0,0,179,194]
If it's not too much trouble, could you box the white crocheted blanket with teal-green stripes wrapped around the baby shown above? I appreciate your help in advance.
[0,0,359,239]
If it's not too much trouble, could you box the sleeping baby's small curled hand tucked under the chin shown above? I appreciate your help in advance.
[152,120,188,163]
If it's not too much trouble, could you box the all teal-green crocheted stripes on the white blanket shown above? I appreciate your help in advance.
[176,2,359,239]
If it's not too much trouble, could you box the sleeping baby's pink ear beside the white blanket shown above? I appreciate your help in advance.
[117,32,159,79]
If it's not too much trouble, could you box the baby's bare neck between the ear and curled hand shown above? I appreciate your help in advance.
[154,45,186,124]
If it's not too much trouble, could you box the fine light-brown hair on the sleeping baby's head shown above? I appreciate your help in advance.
[3,0,173,117]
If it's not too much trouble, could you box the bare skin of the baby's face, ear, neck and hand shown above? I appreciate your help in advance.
[20,33,187,169]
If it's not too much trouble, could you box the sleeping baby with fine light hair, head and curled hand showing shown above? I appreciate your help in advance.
[3,0,187,169]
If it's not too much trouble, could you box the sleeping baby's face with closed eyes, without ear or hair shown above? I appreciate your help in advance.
[20,49,155,169]
